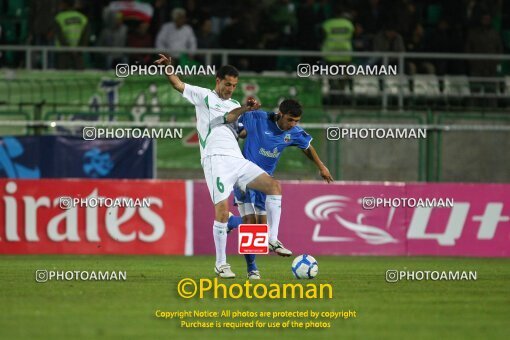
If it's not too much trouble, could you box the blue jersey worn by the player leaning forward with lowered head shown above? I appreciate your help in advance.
[239,111,312,175]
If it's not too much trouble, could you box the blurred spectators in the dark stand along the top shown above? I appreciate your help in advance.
[0,0,510,76]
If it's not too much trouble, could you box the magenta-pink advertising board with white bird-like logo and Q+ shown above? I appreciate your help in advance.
[193,182,510,257]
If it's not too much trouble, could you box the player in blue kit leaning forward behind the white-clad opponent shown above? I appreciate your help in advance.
[228,99,333,279]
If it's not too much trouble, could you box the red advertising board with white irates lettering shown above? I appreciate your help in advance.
[0,179,187,255]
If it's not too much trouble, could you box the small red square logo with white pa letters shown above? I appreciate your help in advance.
[239,224,269,254]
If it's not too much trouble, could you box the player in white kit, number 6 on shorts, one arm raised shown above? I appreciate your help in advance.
[155,54,292,278]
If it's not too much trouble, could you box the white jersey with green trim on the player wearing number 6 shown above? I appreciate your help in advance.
[182,84,244,159]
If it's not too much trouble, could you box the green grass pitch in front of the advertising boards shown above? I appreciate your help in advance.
[0,256,510,339]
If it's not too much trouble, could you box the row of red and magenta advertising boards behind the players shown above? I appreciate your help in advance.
[0,179,510,257]
